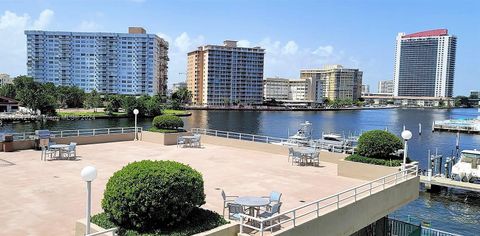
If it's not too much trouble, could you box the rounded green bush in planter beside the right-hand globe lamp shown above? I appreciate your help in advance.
[357,130,403,160]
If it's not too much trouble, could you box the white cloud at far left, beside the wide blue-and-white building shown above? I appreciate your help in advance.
[0,9,55,76]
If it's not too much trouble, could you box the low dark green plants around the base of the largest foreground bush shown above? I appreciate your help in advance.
[92,208,229,236]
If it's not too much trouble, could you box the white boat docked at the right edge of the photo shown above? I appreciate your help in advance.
[451,149,480,183]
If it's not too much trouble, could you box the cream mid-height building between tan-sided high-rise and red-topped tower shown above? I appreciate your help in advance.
[300,65,363,101]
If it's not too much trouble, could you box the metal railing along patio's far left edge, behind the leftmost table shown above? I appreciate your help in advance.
[12,127,143,141]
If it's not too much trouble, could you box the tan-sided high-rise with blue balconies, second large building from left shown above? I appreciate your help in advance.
[187,40,265,105]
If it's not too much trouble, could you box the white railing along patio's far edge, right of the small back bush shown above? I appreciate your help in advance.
[192,128,288,143]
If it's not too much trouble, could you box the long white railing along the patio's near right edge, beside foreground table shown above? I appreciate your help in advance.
[240,165,418,235]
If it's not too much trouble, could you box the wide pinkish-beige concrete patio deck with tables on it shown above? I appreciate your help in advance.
[0,141,366,235]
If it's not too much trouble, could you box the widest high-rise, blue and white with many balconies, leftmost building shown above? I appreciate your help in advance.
[25,27,168,95]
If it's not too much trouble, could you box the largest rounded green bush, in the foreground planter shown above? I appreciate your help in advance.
[102,160,205,232]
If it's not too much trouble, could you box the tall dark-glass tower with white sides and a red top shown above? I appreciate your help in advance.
[394,29,457,97]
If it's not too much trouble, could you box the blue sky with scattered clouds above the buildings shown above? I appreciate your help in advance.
[0,0,480,95]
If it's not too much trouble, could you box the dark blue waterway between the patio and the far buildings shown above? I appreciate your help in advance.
[0,109,480,235]
